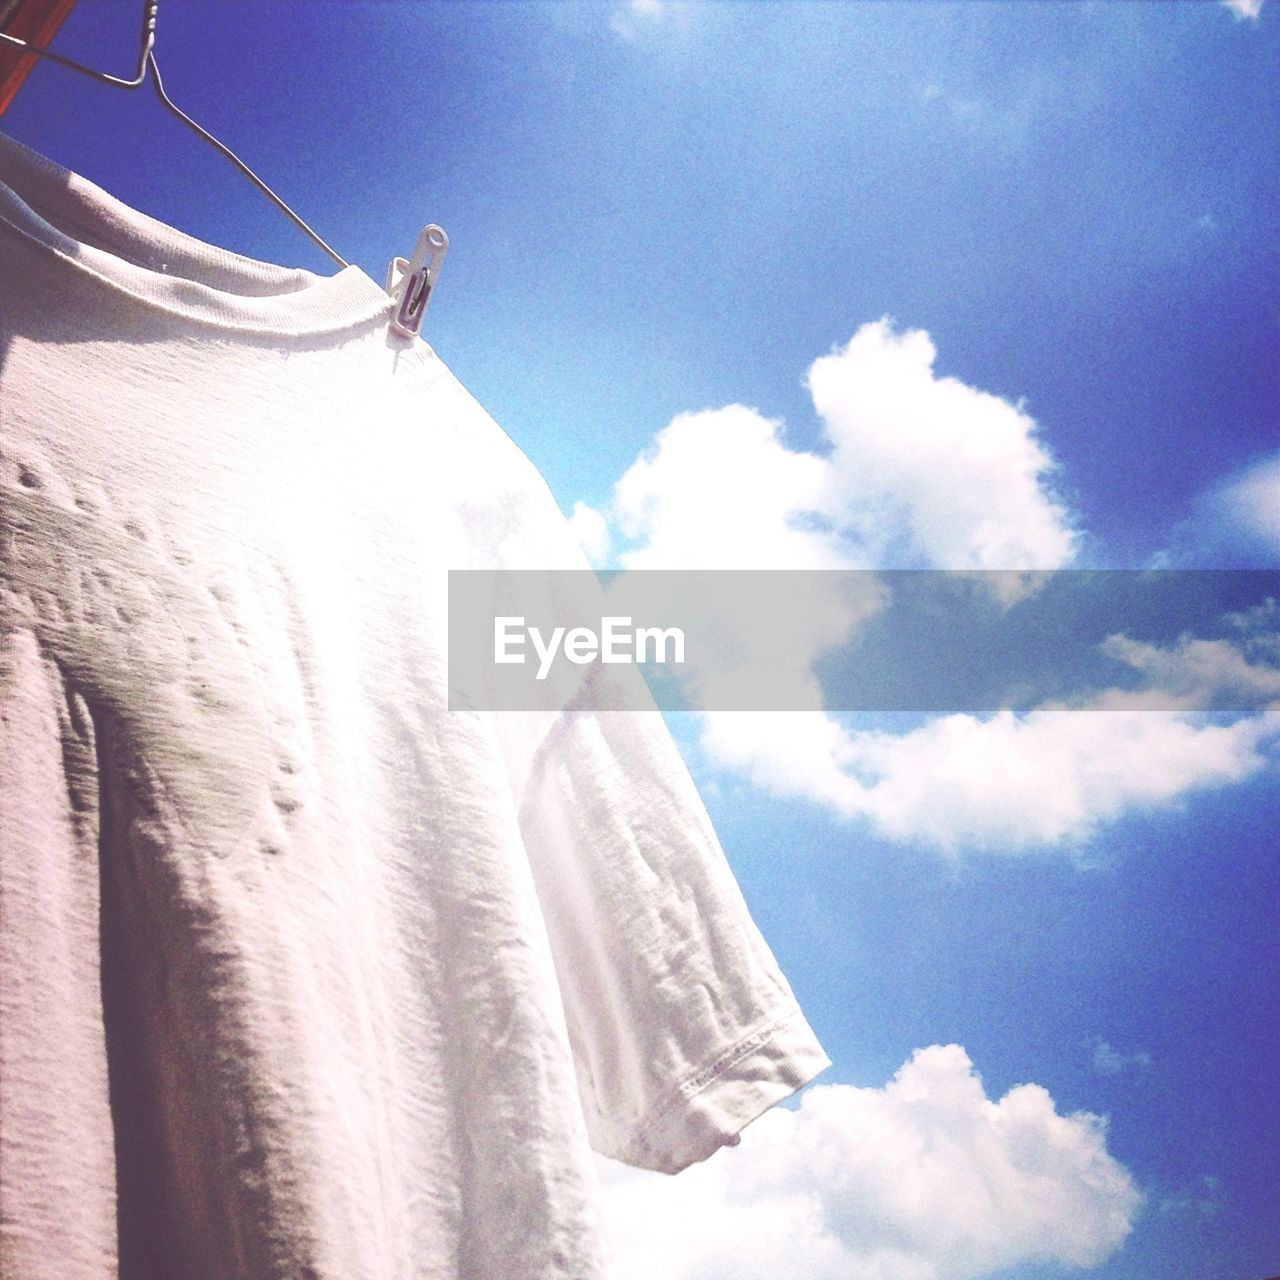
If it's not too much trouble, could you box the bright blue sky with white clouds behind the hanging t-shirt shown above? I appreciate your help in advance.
[3,0,1280,1280]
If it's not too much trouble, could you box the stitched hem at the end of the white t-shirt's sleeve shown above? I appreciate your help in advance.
[621,1005,832,1174]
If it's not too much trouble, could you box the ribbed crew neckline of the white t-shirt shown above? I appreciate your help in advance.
[0,132,392,335]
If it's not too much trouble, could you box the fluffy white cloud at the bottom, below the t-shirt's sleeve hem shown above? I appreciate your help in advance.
[600,1044,1143,1280]
